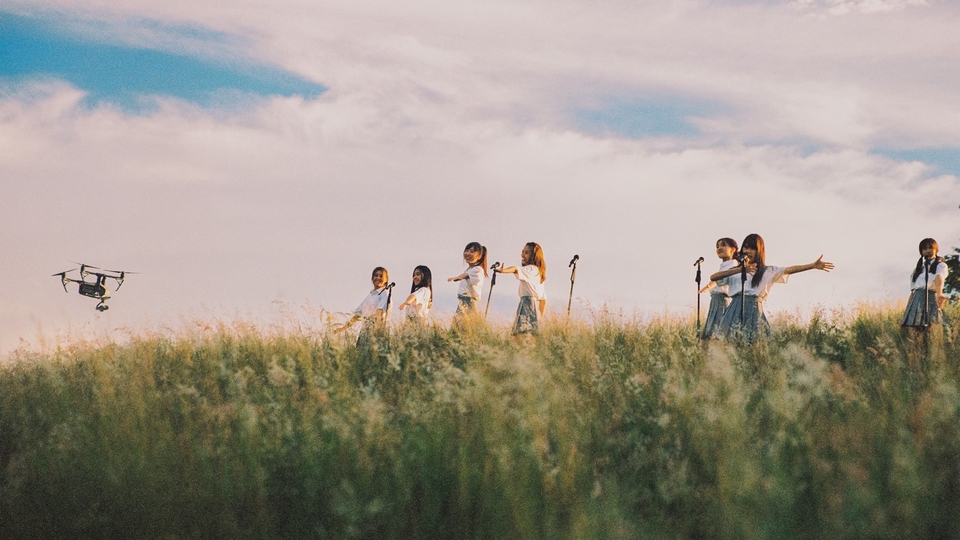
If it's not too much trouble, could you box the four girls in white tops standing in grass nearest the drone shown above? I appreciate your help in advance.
[340,242,547,344]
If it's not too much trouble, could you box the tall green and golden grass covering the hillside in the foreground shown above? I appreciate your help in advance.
[0,307,960,539]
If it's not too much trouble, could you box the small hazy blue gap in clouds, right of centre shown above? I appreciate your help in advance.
[573,95,721,139]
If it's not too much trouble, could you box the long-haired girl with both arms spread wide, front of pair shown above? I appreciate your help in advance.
[710,234,833,343]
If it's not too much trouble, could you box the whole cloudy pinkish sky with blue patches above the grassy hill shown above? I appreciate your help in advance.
[0,0,960,354]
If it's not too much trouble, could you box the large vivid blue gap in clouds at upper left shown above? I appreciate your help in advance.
[0,12,326,110]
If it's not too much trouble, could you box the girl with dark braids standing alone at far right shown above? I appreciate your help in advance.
[900,238,948,330]
